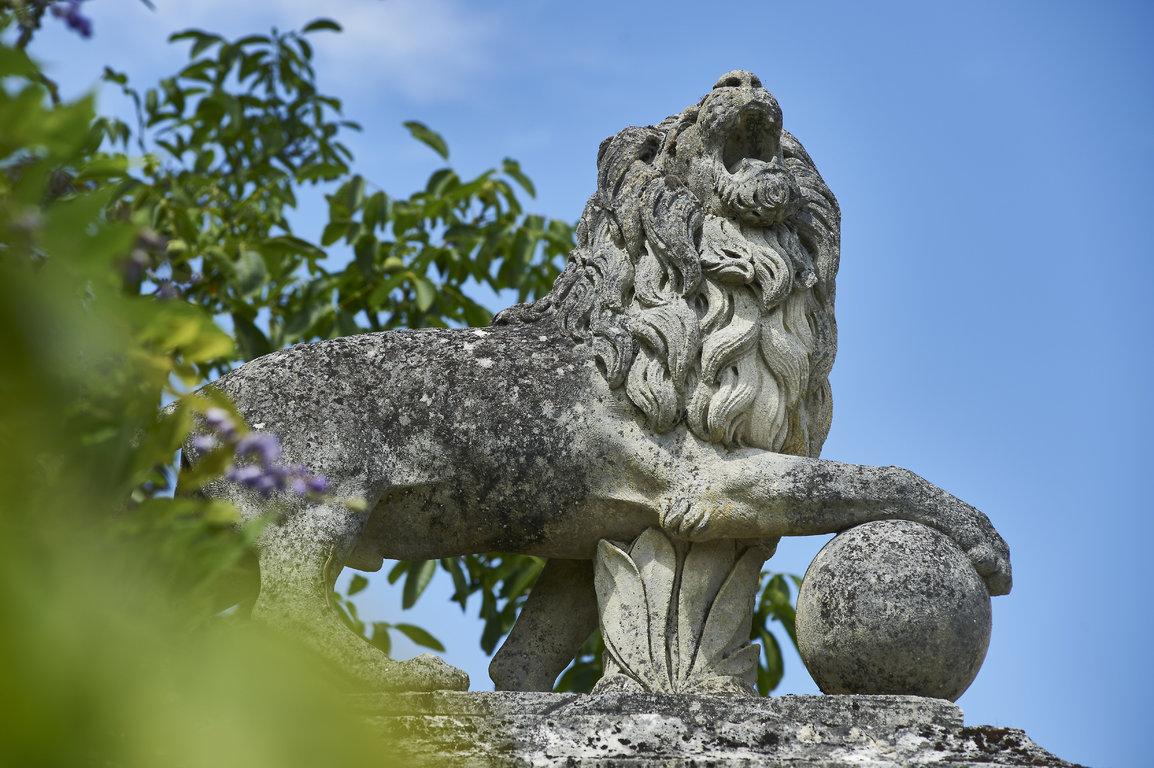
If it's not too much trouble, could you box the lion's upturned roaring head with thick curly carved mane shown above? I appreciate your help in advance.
[494,71,840,457]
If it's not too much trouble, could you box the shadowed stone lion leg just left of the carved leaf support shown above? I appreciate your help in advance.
[489,559,598,691]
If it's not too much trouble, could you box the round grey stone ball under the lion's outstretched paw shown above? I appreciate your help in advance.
[797,520,990,701]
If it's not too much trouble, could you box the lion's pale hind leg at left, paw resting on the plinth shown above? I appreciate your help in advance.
[253,505,469,691]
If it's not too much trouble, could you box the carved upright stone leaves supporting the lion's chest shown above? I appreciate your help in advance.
[594,528,771,695]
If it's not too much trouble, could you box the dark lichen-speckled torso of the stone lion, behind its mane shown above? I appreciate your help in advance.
[205,325,672,570]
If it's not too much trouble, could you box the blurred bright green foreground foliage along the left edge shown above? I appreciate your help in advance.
[0,32,387,768]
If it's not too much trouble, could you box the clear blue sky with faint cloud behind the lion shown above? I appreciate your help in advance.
[22,0,1154,767]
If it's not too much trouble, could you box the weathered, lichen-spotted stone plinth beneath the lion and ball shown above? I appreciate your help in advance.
[354,692,1071,768]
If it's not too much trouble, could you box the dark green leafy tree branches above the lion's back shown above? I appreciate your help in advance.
[104,20,574,377]
